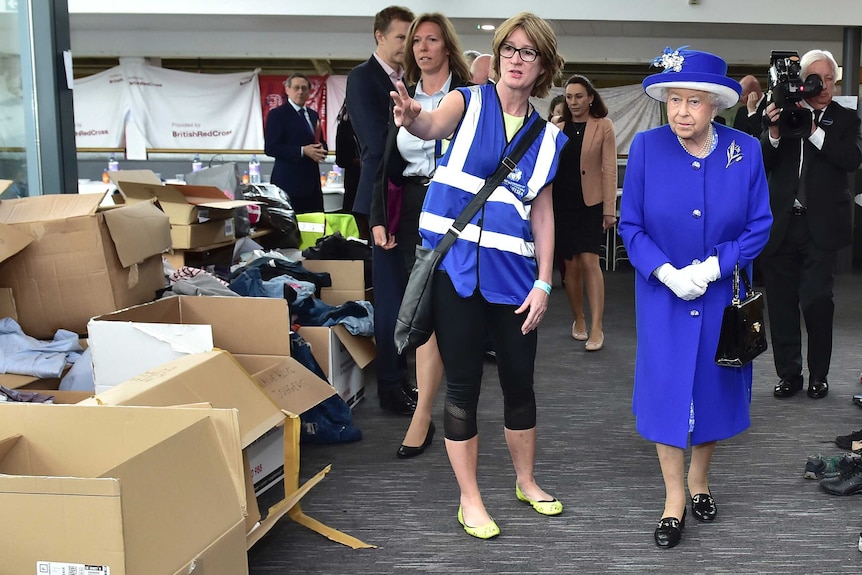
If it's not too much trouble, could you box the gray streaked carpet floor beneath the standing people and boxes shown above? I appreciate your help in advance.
[249,264,862,575]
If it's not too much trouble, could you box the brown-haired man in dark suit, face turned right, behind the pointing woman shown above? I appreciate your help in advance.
[346,6,417,415]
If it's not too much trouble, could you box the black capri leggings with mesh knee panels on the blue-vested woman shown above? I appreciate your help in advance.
[433,271,538,441]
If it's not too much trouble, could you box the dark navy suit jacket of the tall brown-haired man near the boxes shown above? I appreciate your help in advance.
[346,56,395,215]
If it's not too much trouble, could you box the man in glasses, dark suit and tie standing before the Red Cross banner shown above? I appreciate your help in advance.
[264,74,326,214]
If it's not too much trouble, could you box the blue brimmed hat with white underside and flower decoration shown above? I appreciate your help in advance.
[643,46,742,110]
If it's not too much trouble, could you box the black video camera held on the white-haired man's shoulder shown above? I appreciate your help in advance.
[763,50,823,138]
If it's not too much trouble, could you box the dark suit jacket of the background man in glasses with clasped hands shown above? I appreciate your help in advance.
[264,102,326,213]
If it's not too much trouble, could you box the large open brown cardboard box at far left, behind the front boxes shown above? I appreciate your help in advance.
[0,194,171,339]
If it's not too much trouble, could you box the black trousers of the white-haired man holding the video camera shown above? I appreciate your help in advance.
[760,215,835,381]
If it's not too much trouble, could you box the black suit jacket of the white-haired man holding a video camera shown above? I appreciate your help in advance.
[760,102,862,256]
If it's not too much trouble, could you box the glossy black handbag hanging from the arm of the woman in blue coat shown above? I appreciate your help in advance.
[715,264,766,367]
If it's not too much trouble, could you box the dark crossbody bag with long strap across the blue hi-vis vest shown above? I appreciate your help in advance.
[395,118,546,355]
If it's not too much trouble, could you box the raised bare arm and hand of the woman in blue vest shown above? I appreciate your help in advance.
[389,82,464,140]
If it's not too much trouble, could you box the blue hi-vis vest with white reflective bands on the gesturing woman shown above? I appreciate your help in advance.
[419,84,567,305]
